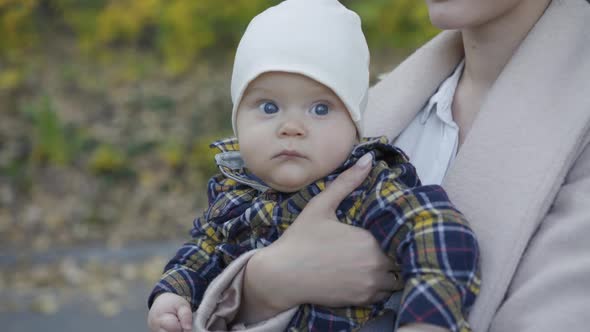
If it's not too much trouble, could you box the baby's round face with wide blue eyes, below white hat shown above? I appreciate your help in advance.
[236,72,357,192]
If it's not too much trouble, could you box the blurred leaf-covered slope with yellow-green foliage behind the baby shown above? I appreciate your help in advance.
[0,0,436,264]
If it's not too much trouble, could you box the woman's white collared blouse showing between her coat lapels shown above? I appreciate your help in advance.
[393,60,465,185]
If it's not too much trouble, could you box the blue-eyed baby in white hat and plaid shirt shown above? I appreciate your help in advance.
[149,0,480,331]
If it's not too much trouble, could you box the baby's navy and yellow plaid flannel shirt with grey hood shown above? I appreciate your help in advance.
[149,137,480,331]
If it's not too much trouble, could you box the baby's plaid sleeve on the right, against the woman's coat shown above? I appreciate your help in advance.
[362,168,480,332]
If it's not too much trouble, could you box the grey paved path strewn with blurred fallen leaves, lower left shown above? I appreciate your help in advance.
[0,239,181,332]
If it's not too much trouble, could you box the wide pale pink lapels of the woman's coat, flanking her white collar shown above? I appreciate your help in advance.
[366,0,590,331]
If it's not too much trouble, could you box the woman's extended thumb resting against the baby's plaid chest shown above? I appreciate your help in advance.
[313,153,373,211]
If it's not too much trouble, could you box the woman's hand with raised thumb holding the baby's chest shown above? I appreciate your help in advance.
[238,154,397,323]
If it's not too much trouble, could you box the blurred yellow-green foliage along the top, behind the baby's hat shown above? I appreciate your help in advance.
[0,0,436,75]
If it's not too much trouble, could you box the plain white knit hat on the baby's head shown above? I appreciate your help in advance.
[231,0,369,135]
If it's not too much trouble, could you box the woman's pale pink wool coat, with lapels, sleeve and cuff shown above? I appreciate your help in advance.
[195,0,590,332]
